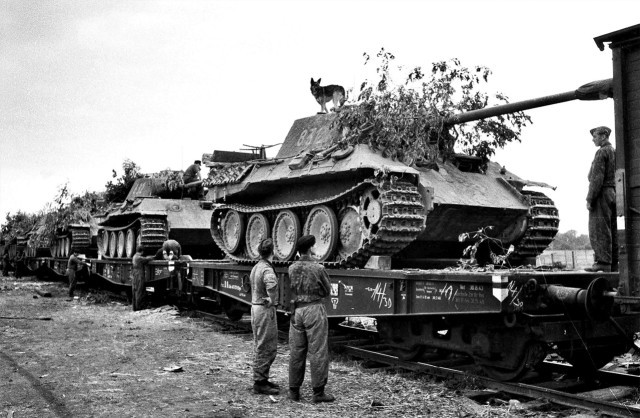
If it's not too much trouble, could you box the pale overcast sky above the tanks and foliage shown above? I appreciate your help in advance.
[0,0,640,233]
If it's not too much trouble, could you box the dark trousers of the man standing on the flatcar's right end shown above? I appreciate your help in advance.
[589,187,618,268]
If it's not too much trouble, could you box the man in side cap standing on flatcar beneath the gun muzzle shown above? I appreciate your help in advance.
[585,126,618,272]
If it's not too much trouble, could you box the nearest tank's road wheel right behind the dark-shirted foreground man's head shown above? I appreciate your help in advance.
[303,205,340,261]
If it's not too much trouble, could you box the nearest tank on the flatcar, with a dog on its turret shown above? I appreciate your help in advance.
[205,80,611,268]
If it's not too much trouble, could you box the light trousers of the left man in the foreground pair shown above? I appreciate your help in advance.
[251,305,278,382]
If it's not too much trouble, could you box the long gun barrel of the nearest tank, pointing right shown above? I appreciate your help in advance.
[444,78,613,125]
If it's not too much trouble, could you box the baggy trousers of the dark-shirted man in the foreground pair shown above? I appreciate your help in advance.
[289,303,329,388]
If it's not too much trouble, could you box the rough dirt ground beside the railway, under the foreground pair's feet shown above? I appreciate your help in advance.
[0,276,592,418]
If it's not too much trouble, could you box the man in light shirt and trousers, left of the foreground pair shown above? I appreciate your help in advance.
[249,238,280,395]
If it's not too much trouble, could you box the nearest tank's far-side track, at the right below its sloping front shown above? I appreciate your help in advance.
[514,191,560,258]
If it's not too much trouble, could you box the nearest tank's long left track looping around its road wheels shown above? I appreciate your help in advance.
[211,179,426,267]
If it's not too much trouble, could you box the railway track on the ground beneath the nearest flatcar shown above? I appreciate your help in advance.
[190,311,640,417]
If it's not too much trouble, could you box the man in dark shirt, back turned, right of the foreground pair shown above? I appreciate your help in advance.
[289,235,335,403]
